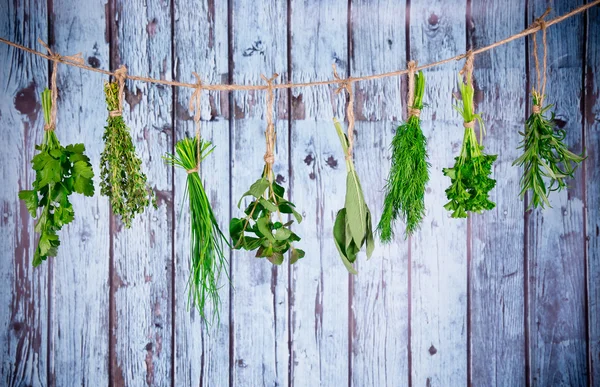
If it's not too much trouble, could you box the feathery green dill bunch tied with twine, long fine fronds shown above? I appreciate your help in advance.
[377,68,429,243]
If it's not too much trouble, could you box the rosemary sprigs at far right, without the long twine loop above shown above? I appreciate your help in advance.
[513,93,585,208]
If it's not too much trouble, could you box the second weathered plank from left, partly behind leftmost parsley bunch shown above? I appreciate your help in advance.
[50,0,110,386]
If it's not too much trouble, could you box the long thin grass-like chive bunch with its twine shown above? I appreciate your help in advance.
[164,73,229,325]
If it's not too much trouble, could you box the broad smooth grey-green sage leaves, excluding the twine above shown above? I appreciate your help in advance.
[333,118,375,274]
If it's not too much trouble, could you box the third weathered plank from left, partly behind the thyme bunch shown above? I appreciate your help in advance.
[111,0,173,386]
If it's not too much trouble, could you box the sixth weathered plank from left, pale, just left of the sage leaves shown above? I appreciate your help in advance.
[290,1,349,386]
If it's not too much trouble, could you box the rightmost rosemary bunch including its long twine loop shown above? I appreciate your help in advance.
[513,8,585,208]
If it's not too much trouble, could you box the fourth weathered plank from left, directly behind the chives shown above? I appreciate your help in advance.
[173,1,230,386]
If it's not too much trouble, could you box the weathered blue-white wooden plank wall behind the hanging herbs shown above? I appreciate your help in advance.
[0,0,600,386]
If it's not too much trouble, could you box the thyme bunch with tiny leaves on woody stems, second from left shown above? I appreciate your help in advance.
[100,73,156,228]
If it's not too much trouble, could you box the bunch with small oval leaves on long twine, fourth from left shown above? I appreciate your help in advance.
[229,74,305,265]
